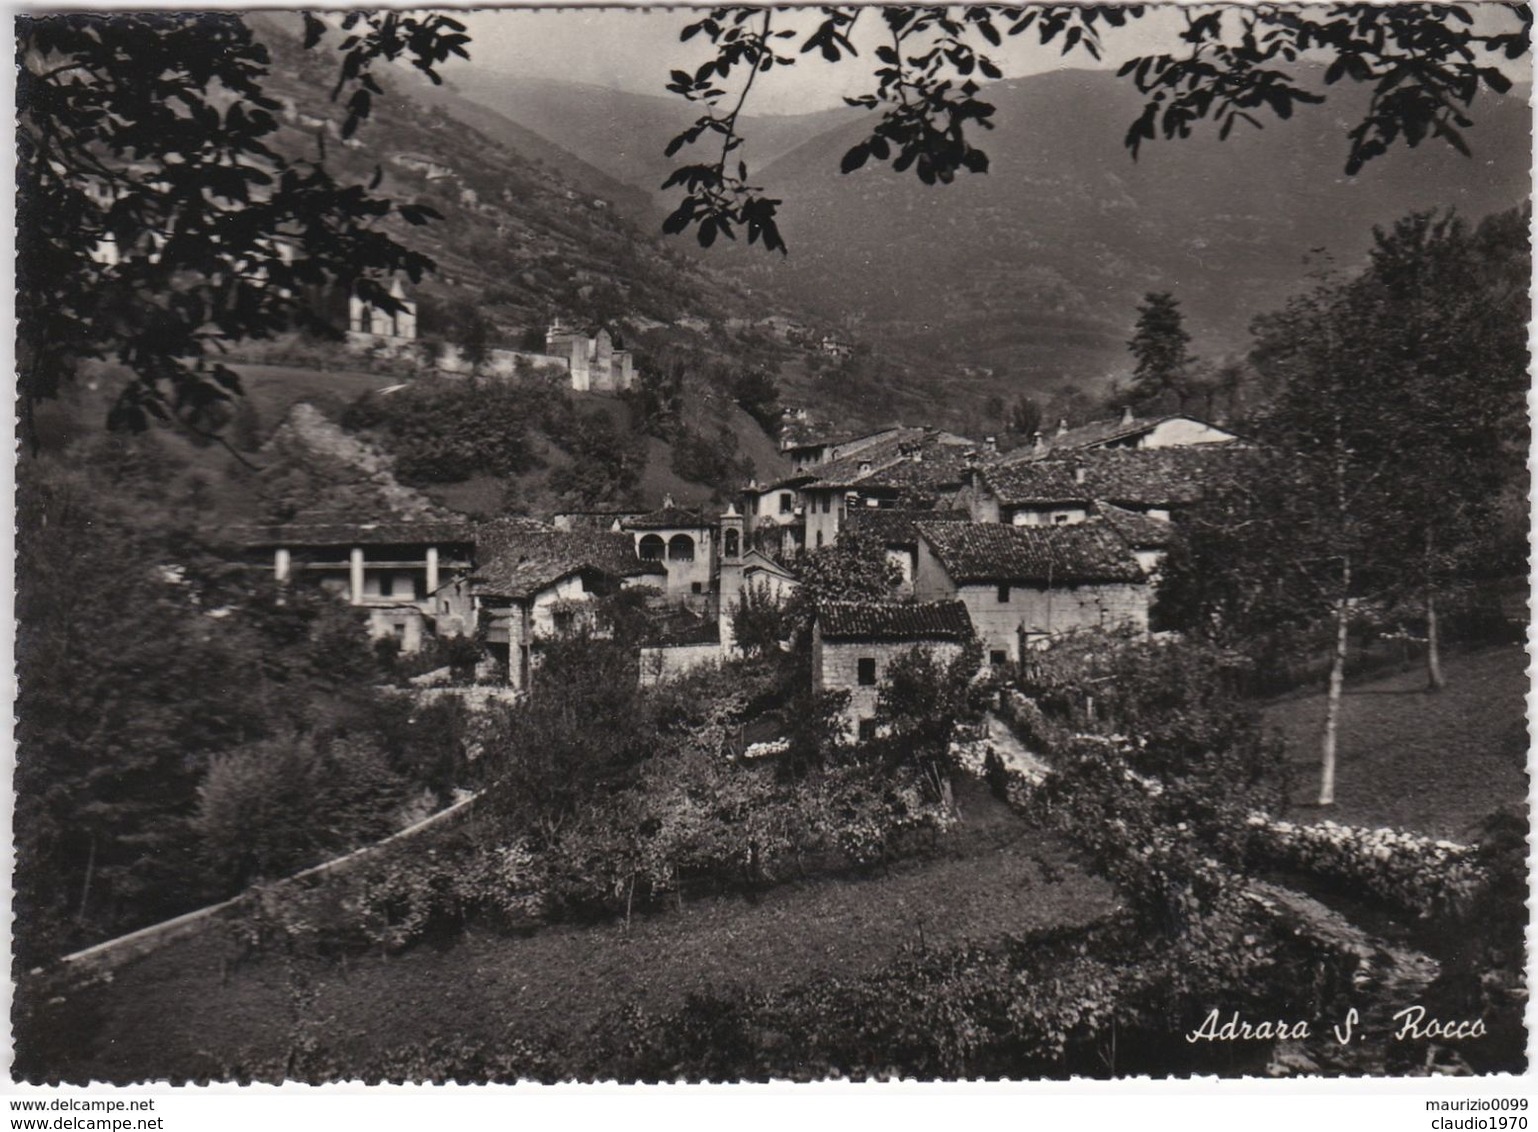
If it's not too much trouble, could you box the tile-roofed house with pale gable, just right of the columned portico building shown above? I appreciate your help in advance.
[432,520,666,692]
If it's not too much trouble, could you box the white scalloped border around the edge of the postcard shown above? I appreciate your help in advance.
[0,0,1538,1113]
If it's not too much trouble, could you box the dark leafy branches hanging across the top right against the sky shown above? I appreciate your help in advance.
[663,5,1532,252]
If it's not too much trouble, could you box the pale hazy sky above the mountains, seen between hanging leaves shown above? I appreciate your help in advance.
[446,8,1181,114]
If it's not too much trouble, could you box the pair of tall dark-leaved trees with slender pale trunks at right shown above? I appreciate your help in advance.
[1166,203,1529,804]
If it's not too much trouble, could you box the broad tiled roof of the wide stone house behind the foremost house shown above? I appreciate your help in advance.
[918,521,1143,584]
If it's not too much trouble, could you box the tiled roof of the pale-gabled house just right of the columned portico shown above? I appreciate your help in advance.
[474,520,667,598]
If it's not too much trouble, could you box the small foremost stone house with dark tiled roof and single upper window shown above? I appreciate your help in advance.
[812,600,974,738]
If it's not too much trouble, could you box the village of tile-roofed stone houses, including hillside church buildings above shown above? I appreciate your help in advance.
[231,335,1247,738]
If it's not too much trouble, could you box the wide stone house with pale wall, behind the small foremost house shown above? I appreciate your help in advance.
[914,520,1149,664]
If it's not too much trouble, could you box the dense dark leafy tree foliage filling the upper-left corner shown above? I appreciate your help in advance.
[17,12,466,432]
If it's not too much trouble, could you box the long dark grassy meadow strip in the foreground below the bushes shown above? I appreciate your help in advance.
[39,783,1115,1083]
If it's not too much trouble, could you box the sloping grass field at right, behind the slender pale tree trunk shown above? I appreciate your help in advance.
[1266,646,1529,838]
